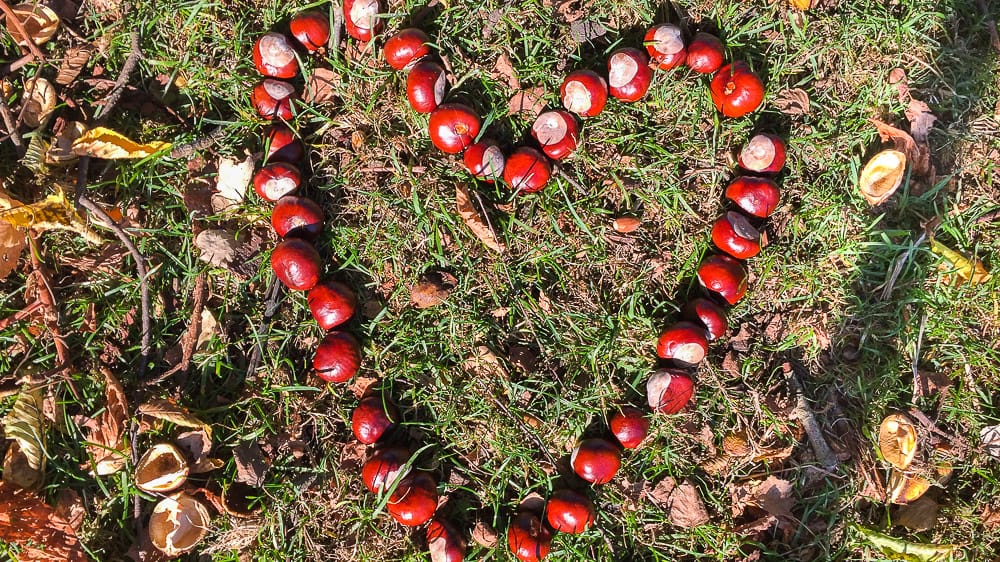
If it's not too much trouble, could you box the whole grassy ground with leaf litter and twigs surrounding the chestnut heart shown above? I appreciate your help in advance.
[0,0,1000,561]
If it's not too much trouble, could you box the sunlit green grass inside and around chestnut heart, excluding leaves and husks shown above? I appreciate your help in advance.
[0,0,1000,561]
